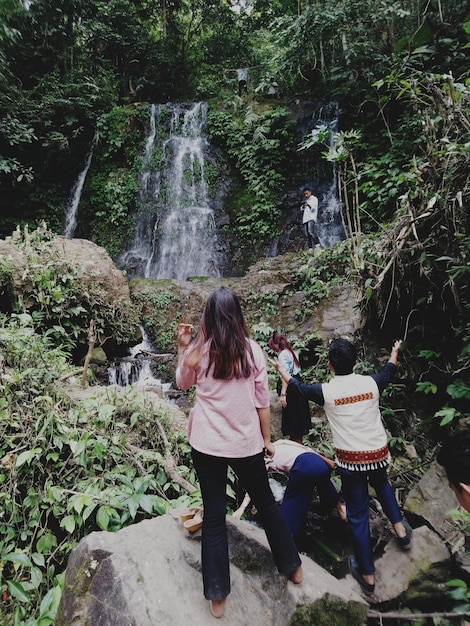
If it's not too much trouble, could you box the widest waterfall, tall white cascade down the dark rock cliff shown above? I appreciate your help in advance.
[118,102,220,280]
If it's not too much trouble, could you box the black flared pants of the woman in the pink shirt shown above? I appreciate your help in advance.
[191,448,301,600]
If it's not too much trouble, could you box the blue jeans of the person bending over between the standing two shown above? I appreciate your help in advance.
[281,452,338,537]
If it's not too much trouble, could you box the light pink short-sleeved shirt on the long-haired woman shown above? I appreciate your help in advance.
[176,339,269,458]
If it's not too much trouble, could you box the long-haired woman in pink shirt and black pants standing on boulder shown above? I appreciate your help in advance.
[176,287,302,617]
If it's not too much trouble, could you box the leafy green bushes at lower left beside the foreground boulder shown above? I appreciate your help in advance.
[0,315,195,626]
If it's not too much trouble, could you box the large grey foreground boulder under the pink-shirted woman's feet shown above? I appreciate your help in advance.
[55,511,368,626]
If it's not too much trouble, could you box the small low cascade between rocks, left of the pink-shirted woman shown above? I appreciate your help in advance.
[108,327,171,394]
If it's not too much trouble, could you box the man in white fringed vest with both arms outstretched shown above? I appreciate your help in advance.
[272,339,412,593]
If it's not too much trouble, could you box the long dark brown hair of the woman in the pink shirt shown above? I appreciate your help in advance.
[187,287,253,380]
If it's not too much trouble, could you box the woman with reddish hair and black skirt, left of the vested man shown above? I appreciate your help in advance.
[268,332,312,443]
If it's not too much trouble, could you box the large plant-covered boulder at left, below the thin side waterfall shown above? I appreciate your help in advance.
[0,226,141,357]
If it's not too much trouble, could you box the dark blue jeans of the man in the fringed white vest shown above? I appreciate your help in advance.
[337,467,402,574]
